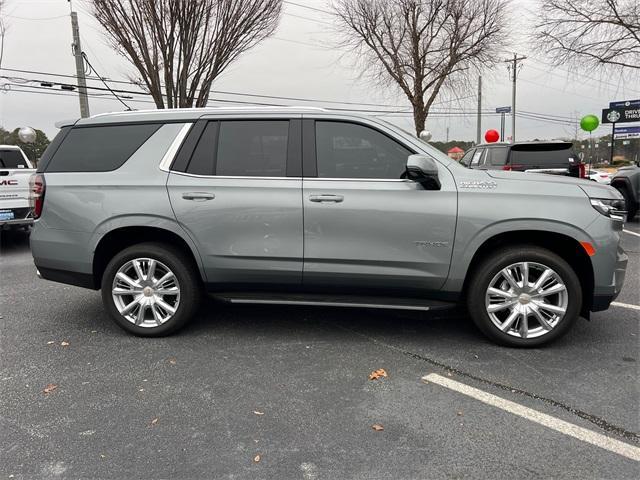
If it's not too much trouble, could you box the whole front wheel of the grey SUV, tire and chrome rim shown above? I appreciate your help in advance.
[467,245,582,347]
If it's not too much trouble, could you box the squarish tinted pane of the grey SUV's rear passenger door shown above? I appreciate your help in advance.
[216,120,289,177]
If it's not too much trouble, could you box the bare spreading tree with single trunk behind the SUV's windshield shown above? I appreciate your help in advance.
[334,0,508,133]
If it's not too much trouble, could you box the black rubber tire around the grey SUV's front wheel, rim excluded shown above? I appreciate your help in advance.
[467,245,582,347]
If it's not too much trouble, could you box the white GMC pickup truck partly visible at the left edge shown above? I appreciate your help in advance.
[0,145,35,230]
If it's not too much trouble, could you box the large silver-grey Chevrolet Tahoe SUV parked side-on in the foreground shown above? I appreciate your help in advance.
[31,108,627,346]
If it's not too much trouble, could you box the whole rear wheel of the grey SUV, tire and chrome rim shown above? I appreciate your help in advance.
[102,243,201,337]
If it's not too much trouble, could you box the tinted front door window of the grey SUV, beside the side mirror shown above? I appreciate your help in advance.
[316,122,413,179]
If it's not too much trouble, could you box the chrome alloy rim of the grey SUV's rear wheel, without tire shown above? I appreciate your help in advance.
[111,258,180,328]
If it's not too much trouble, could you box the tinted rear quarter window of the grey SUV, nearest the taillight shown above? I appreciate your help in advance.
[46,124,160,172]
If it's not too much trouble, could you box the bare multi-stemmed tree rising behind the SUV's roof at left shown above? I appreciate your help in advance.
[91,0,282,108]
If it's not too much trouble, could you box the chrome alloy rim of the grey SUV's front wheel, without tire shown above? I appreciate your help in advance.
[485,262,569,338]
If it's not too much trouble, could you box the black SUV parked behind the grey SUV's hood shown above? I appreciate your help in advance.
[460,142,586,178]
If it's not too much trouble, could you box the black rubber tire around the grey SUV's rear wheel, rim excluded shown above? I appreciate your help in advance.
[101,243,202,337]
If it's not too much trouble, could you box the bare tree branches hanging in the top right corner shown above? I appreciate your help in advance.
[536,0,640,69]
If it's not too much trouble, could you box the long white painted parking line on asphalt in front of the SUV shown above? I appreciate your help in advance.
[422,373,640,461]
